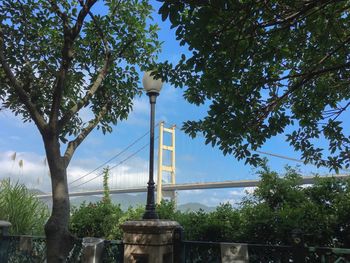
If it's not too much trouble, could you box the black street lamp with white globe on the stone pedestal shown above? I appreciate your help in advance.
[142,71,163,219]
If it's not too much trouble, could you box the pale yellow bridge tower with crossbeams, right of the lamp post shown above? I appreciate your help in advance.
[157,121,176,204]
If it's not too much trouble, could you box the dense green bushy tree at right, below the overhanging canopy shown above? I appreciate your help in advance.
[239,166,350,247]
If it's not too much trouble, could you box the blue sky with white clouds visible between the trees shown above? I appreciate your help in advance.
[0,1,346,209]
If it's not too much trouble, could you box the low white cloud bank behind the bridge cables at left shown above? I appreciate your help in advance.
[0,151,148,192]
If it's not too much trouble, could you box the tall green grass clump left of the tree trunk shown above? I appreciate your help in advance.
[0,179,49,235]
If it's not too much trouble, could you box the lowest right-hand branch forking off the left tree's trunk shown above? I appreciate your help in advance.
[63,102,109,166]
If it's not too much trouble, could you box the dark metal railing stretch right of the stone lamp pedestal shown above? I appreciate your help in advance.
[182,241,350,263]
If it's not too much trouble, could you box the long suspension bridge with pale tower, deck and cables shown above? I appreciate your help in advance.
[37,122,349,203]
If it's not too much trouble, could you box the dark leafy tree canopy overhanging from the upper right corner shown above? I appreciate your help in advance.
[159,0,350,170]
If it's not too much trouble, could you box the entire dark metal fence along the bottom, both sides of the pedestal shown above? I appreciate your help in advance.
[0,236,350,263]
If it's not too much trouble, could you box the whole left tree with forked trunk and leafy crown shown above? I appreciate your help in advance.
[0,0,160,262]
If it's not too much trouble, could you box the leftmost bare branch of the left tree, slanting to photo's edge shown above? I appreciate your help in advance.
[0,27,47,134]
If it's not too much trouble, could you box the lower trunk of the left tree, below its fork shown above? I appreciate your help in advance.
[44,137,73,263]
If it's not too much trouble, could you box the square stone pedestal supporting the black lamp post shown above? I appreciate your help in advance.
[122,220,180,263]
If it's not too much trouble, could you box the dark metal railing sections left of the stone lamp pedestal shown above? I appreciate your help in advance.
[0,236,124,263]
